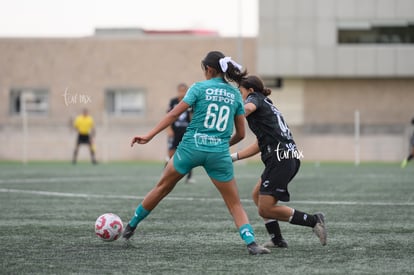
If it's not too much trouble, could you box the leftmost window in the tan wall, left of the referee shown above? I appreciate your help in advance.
[10,88,49,115]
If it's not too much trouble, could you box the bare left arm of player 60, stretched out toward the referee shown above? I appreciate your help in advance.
[131,101,190,147]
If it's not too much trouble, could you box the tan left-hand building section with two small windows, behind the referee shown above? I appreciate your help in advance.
[0,29,256,161]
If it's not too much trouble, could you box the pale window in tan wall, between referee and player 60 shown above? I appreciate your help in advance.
[105,88,145,116]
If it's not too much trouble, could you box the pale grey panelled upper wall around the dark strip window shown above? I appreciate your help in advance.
[258,0,414,77]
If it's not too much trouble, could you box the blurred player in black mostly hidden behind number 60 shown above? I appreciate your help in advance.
[166,83,195,183]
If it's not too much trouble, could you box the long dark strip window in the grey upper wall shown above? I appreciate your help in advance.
[338,22,414,44]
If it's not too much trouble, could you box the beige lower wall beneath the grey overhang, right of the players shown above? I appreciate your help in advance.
[271,78,414,161]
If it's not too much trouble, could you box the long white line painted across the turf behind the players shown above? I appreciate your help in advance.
[0,188,414,206]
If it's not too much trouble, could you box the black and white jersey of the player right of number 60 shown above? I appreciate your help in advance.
[245,92,296,158]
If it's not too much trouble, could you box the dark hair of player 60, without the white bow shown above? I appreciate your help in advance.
[201,51,247,85]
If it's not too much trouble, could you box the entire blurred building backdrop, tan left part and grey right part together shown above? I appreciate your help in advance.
[0,0,414,161]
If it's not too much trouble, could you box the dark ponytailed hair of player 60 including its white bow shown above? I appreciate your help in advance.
[201,51,247,85]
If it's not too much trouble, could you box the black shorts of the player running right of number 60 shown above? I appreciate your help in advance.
[259,154,300,201]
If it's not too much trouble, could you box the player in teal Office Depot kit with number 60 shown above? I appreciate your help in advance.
[123,51,270,255]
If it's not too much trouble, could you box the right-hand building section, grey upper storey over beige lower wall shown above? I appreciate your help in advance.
[257,0,414,161]
